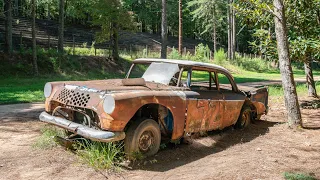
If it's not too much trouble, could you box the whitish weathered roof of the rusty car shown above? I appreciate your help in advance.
[133,58,230,75]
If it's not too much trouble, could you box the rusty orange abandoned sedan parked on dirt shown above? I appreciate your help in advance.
[39,59,268,156]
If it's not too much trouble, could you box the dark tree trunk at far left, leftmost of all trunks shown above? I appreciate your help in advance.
[4,0,12,54]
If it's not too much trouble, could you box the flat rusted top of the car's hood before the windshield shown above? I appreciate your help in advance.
[55,79,185,91]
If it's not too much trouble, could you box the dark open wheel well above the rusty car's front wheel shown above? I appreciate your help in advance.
[124,104,174,136]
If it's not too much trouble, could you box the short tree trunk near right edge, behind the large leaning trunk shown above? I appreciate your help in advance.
[304,53,318,97]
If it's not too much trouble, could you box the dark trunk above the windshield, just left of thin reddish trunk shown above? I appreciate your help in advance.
[161,0,168,59]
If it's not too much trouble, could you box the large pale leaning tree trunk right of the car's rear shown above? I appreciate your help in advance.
[273,0,301,127]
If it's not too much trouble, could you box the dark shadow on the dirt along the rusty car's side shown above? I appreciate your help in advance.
[132,121,277,172]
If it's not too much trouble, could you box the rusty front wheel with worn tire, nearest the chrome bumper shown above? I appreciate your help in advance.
[124,119,161,158]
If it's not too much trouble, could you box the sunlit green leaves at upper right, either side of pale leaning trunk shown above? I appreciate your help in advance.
[235,0,320,62]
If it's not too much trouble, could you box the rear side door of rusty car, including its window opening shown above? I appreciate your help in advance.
[218,72,245,128]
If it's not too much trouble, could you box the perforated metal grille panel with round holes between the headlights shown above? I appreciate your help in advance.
[57,89,90,107]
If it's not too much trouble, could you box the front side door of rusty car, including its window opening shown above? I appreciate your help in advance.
[185,71,223,133]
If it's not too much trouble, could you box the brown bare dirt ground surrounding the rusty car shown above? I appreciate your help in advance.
[0,98,320,179]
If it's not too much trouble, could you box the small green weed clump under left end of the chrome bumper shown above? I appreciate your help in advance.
[33,125,66,149]
